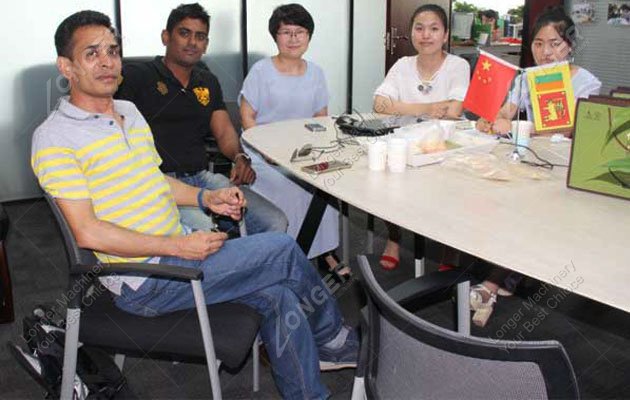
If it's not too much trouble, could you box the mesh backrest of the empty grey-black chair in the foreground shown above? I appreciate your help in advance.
[359,256,579,399]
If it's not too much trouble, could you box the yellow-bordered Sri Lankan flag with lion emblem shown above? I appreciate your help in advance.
[526,61,575,131]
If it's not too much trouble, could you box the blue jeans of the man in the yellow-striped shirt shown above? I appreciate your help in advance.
[116,233,343,399]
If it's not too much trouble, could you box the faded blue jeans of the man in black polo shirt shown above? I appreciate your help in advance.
[167,170,289,235]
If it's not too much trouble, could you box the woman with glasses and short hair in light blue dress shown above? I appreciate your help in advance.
[239,4,350,281]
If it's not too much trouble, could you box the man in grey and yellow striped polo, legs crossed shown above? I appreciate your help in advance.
[32,11,358,398]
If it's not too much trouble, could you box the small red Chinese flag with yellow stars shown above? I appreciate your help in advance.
[464,51,518,122]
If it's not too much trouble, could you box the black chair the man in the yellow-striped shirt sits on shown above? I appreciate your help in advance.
[45,194,260,399]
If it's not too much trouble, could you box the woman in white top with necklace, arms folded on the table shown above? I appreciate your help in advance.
[374,4,470,269]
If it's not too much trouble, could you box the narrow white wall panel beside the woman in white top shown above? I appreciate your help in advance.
[352,0,387,112]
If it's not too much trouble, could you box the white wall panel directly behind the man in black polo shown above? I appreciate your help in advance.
[121,0,243,101]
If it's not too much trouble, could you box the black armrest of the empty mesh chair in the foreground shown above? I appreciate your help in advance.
[387,270,471,307]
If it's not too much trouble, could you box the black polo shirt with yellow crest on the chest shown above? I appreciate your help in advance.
[115,56,225,173]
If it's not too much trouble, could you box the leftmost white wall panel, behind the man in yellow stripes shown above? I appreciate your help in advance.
[0,0,114,201]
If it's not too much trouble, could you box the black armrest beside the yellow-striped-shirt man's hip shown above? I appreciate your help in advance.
[70,263,203,281]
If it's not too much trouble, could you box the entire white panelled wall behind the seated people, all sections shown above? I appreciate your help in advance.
[0,0,385,201]
